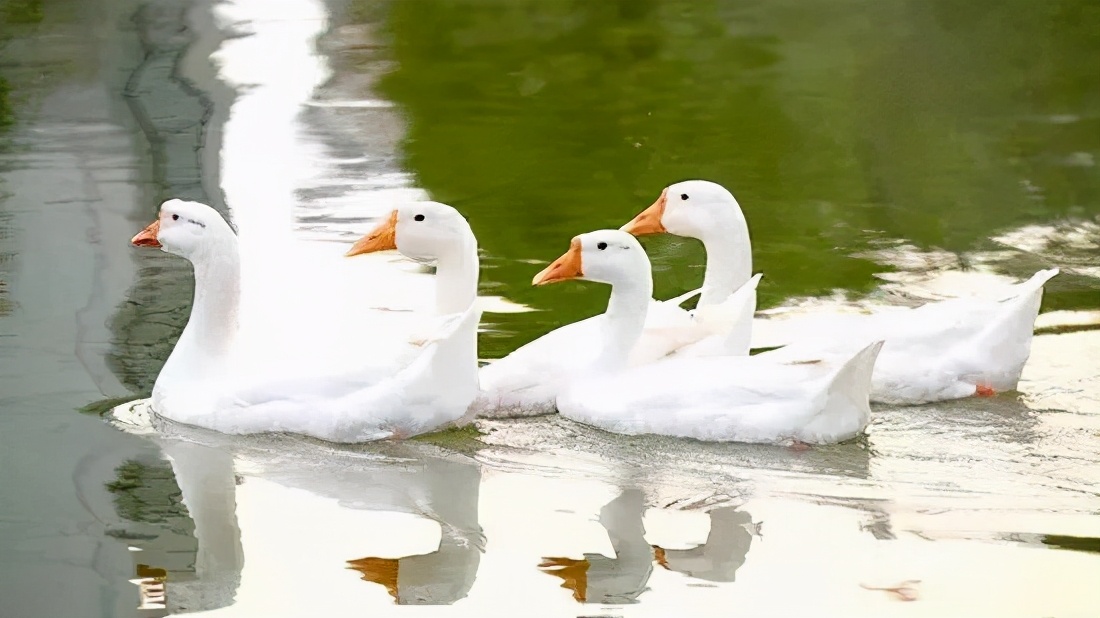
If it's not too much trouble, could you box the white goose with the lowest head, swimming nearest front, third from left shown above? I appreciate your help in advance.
[534,230,882,443]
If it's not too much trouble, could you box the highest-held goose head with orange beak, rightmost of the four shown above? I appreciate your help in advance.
[622,180,740,240]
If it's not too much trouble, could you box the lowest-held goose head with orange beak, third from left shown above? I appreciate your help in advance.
[531,230,649,286]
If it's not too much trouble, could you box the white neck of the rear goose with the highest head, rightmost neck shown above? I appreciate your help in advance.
[699,200,752,307]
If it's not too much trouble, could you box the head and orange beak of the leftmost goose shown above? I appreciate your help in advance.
[130,199,237,260]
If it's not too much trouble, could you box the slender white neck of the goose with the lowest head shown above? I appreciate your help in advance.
[593,268,653,371]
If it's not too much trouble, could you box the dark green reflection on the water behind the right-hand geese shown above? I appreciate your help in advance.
[374,0,1100,356]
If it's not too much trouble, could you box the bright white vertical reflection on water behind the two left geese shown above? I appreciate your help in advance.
[205,0,528,372]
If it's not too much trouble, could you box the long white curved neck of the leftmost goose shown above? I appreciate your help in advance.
[153,236,241,395]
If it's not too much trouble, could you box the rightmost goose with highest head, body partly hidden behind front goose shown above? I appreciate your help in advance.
[623,180,1058,404]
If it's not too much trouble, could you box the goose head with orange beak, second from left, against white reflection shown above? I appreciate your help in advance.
[345,201,476,262]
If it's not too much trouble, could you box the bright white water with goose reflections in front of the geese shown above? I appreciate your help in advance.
[105,404,1100,616]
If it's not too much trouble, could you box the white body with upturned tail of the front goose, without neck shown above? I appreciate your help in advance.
[558,342,882,444]
